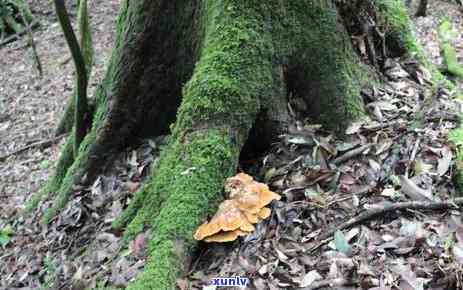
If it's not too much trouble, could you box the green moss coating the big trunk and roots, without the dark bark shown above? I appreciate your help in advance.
[40,0,442,289]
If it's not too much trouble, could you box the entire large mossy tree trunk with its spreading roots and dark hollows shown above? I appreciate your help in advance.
[31,0,424,289]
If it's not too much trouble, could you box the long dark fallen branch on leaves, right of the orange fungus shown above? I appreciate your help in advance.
[310,197,463,252]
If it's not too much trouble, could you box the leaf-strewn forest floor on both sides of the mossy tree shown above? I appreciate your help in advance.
[0,0,463,290]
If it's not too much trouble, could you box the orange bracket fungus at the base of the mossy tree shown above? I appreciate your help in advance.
[194,173,281,243]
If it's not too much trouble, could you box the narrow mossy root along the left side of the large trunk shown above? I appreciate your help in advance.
[28,0,138,223]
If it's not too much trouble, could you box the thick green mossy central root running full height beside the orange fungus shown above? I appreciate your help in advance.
[128,1,273,290]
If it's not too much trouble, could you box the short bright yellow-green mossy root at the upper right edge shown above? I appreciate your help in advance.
[438,20,463,80]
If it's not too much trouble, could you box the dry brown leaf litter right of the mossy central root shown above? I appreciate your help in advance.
[182,1,463,290]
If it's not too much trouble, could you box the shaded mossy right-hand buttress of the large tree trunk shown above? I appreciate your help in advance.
[276,1,372,132]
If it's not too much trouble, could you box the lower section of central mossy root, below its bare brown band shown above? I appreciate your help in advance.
[129,132,242,290]
